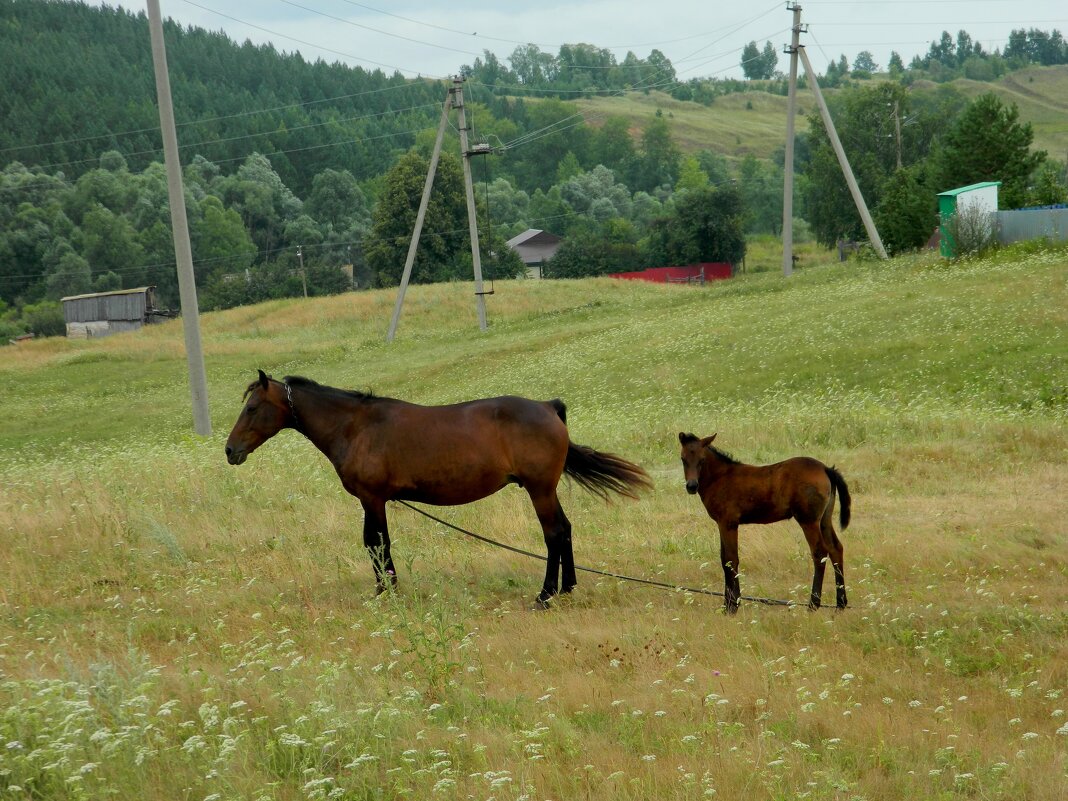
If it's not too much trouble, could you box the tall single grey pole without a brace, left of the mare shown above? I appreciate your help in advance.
[147,0,211,437]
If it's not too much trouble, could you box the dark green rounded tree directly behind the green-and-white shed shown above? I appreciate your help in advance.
[935,92,1047,208]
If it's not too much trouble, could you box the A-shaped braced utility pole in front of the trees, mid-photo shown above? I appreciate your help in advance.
[386,78,491,342]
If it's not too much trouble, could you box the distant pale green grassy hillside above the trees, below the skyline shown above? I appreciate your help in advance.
[577,65,1068,159]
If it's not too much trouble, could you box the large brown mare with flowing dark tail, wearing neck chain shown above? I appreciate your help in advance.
[226,371,651,606]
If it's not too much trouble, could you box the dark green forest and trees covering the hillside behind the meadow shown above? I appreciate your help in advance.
[0,0,1065,341]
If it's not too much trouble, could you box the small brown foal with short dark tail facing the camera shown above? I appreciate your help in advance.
[678,431,851,613]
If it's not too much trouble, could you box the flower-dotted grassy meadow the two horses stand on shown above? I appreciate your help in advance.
[0,249,1068,801]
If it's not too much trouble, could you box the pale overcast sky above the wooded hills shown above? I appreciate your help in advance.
[104,0,1068,80]
